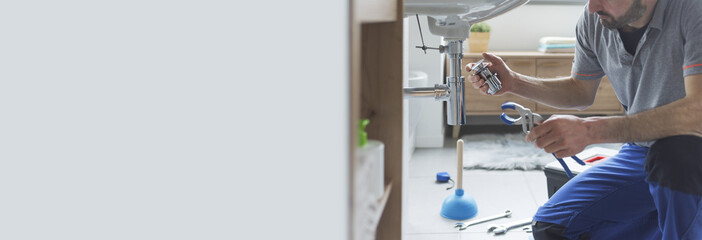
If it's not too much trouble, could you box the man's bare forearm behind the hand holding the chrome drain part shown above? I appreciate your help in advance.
[510,74,599,110]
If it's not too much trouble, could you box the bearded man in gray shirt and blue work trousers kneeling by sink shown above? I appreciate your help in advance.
[468,0,702,240]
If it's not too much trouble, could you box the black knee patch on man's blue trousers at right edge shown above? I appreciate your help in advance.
[646,135,702,195]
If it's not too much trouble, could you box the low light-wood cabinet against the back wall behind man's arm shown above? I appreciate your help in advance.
[463,52,624,116]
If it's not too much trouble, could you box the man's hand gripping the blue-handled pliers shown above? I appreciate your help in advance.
[526,115,592,158]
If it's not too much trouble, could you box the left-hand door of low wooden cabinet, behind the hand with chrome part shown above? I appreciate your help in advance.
[462,58,536,115]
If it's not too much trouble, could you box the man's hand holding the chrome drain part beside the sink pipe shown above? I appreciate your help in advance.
[466,53,514,96]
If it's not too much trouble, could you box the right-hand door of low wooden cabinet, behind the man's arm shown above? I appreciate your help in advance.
[536,58,622,114]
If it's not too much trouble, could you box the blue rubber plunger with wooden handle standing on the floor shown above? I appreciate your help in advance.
[441,139,478,220]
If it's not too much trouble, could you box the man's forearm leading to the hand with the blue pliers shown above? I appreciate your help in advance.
[585,98,702,143]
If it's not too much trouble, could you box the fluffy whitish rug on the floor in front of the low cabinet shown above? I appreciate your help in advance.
[463,133,622,170]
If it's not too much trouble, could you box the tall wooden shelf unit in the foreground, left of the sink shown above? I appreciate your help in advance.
[348,0,404,240]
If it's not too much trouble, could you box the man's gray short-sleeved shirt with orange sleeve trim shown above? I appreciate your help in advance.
[572,0,702,146]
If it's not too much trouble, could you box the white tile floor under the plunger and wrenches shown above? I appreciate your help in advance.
[403,140,548,240]
